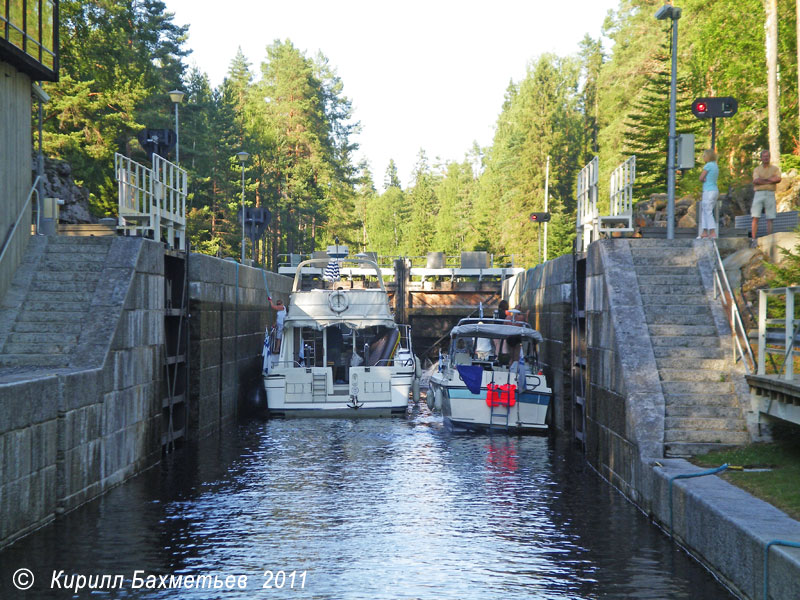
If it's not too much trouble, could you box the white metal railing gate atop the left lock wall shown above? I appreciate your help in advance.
[114,153,187,250]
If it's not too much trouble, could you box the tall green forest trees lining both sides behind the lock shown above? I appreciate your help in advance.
[39,0,800,267]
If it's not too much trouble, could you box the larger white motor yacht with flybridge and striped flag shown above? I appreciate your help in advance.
[264,258,416,416]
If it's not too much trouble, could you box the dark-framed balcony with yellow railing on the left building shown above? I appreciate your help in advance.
[0,0,58,81]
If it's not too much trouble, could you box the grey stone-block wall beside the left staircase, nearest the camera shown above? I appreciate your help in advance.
[0,238,163,546]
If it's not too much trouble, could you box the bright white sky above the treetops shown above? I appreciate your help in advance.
[165,0,618,190]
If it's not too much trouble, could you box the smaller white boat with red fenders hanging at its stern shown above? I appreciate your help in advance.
[427,318,553,432]
